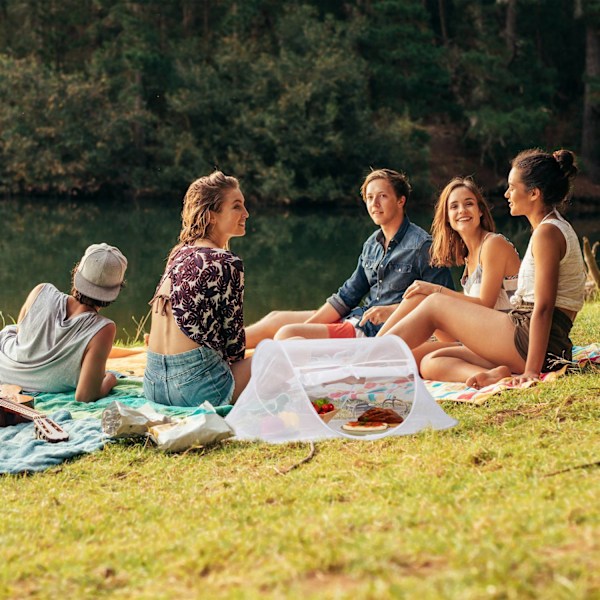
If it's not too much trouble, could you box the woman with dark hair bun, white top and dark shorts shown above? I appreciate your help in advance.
[387,149,585,388]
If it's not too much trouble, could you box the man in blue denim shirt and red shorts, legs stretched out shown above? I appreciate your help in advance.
[246,169,454,348]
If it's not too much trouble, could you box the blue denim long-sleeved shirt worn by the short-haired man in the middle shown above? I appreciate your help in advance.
[327,216,454,336]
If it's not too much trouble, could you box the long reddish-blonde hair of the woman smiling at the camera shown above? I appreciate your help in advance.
[430,177,496,267]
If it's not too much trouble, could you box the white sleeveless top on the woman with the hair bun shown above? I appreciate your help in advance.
[511,209,585,312]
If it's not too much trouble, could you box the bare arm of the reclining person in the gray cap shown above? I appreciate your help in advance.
[75,323,117,402]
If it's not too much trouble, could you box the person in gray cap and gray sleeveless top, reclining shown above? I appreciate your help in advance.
[0,243,127,402]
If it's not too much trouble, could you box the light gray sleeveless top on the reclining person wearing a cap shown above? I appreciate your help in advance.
[0,283,112,392]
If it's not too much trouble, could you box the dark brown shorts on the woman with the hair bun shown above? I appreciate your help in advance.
[508,308,573,373]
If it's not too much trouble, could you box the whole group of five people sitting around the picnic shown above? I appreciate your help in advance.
[0,149,585,406]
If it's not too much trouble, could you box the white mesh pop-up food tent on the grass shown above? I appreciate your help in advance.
[226,336,457,443]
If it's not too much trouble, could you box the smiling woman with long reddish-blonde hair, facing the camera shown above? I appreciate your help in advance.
[376,177,521,364]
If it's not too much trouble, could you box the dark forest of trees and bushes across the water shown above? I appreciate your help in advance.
[0,0,600,204]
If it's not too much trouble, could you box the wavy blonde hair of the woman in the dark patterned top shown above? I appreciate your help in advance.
[170,171,240,256]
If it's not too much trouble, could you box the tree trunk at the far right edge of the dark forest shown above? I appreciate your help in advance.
[581,24,600,183]
